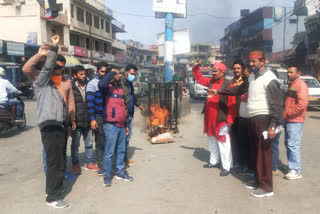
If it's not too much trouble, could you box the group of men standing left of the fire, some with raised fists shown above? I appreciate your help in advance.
[23,35,143,208]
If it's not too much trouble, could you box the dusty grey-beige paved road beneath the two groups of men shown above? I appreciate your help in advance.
[0,98,320,214]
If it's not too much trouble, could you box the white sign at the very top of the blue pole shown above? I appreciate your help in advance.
[153,0,187,18]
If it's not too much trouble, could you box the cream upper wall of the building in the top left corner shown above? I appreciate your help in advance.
[0,0,42,44]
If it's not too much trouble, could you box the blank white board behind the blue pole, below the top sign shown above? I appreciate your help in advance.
[158,29,190,57]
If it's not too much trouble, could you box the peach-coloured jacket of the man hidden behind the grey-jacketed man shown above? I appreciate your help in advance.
[22,51,76,121]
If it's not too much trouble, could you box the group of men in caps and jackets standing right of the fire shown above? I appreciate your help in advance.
[192,51,308,197]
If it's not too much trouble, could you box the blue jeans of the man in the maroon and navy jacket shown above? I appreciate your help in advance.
[103,123,126,178]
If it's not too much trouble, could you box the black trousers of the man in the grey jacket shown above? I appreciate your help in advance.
[41,125,65,202]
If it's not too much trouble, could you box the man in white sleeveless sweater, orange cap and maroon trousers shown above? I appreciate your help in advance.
[210,51,283,197]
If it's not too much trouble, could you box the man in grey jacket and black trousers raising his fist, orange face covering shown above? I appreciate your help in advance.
[33,35,73,208]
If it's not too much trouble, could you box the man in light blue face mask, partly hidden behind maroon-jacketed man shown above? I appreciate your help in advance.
[121,64,144,165]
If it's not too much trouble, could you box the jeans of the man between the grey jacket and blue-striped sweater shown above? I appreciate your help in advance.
[71,127,93,166]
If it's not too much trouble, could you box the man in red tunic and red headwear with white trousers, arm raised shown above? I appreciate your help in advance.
[192,59,236,176]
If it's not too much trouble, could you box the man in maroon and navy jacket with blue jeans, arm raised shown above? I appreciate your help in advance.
[98,69,133,186]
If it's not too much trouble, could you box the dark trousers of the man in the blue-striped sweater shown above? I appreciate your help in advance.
[94,116,104,169]
